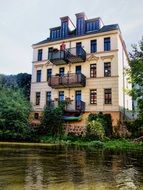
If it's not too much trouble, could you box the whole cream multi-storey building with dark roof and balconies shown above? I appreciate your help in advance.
[31,13,132,125]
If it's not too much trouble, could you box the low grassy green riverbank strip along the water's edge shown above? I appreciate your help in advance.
[0,138,143,151]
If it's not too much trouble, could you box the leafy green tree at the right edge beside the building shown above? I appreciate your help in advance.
[126,38,143,120]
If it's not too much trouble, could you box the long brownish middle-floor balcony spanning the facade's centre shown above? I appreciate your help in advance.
[48,73,86,89]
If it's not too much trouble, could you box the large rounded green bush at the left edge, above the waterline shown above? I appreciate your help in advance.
[0,87,31,140]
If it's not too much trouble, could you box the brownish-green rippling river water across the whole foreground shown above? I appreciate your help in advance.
[0,146,143,190]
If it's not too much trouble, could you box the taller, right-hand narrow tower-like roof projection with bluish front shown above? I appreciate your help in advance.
[75,12,86,35]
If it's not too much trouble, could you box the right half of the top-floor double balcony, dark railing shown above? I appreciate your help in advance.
[67,47,86,63]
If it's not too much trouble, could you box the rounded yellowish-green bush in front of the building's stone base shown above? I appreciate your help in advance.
[87,120,105,139]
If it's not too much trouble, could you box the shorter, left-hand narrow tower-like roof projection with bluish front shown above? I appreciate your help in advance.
[60,16,69,38]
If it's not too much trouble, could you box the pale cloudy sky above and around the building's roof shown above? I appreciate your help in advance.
[0,0,143,74]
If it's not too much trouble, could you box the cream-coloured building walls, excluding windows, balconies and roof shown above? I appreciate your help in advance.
[31,14,132,125]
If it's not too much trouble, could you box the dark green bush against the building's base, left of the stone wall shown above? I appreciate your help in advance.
[41,107,64,136]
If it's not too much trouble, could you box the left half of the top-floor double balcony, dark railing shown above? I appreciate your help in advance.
[48,49,67,65]
